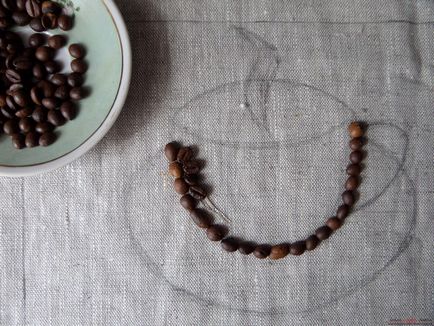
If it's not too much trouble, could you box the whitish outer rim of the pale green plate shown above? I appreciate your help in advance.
[0,0,132,177]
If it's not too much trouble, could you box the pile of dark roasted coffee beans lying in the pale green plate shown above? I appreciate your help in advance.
[0,0,87,149]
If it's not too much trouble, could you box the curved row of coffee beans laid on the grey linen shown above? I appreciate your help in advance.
[164,122,365,260]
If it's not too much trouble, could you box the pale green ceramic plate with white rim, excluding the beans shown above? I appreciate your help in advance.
[0,0,131,176]
